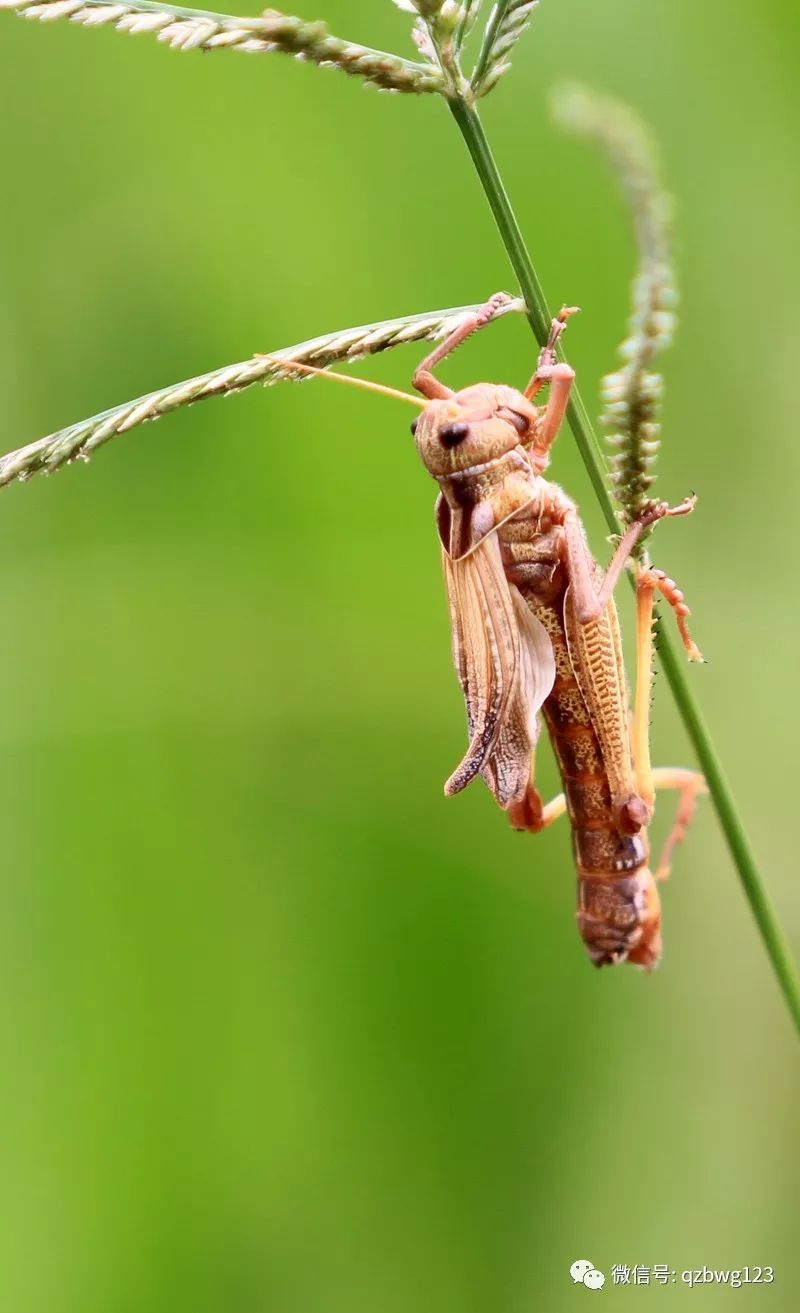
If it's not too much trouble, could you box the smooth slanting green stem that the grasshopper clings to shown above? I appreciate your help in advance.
[448,100,800,1031]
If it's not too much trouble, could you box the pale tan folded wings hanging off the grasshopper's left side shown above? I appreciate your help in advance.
[443,533,556,807]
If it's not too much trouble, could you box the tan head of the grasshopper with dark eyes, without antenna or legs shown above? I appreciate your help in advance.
[411,383,537,478]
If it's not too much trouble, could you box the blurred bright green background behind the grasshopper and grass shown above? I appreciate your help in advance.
[0,0,800,1313]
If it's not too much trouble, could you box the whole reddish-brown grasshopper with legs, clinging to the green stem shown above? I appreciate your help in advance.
[266,300,704,969]
